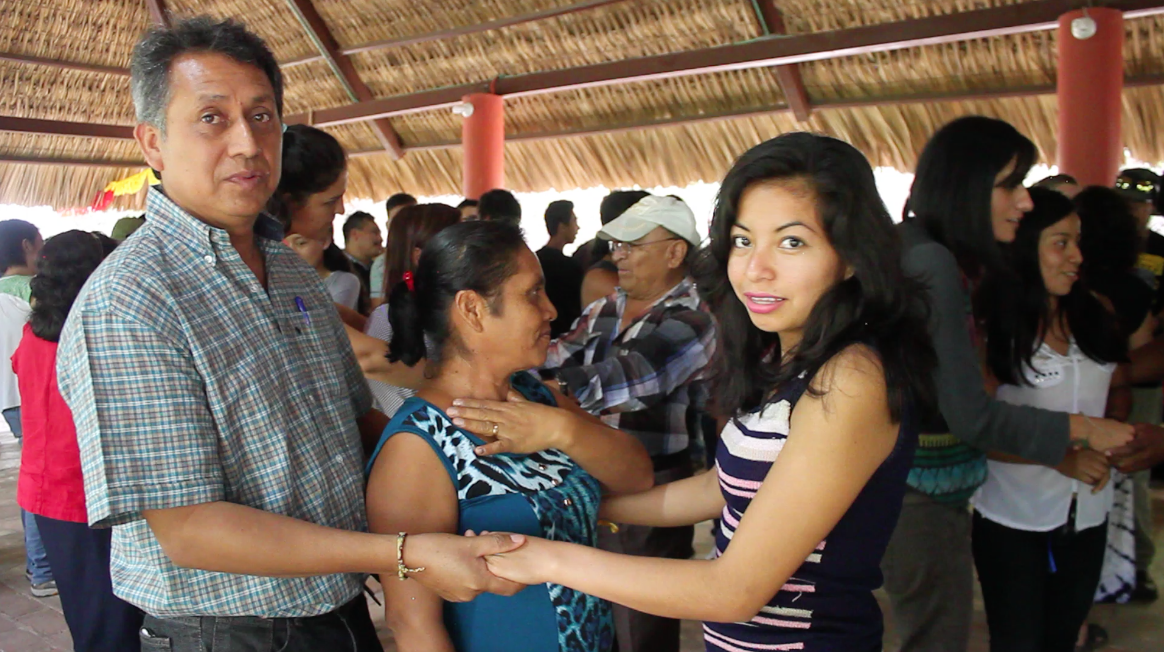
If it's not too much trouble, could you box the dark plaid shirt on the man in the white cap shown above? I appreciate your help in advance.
[544,278,716,456]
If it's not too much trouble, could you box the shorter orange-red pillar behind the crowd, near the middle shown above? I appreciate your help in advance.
[461,93,505,199]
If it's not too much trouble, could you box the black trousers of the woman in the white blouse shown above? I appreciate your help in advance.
[973,512,1107,652]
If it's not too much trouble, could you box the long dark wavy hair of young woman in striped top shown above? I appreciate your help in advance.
[698,133,937,420]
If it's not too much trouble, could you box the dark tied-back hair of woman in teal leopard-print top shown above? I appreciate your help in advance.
[388,221,525,367]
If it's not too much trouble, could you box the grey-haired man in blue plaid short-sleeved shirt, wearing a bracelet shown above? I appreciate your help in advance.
[58,17,521,652]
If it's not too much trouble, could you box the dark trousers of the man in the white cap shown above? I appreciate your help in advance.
[598,452,695,652]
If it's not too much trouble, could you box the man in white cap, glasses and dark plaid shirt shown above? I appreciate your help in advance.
[542,197,716,652]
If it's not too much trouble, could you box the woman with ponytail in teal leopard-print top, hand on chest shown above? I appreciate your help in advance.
[367,217,653,652]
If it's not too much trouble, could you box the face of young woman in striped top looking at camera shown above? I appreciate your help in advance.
[728,179,851,352]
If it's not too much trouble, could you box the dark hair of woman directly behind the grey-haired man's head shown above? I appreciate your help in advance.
[267,125,348,233]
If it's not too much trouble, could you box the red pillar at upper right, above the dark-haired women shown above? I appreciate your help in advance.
[1058,7,1123,186]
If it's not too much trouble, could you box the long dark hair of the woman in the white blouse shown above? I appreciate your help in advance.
[975,187,1128,385]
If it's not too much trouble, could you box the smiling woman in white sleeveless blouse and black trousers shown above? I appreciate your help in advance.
[973,189,1127,652]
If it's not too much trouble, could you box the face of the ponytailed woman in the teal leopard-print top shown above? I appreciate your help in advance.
[477,247,558,370]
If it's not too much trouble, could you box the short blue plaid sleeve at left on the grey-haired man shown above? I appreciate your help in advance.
[57,306,223,527]
